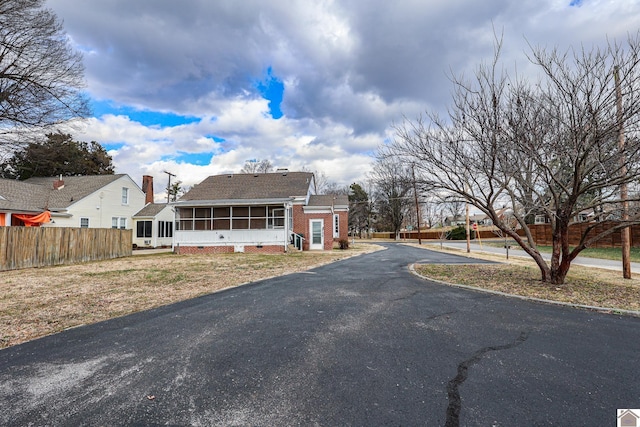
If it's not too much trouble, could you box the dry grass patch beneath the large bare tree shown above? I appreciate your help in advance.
[415,246,640,311]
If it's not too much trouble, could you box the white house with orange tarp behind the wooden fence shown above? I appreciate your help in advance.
[0,174,145,239]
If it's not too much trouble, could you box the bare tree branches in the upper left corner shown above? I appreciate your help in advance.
[0,0,89,146]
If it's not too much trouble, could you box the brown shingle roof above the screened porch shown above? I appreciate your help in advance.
[179,172,313,202]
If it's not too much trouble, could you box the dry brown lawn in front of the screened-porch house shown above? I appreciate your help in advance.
[0,244,381,348]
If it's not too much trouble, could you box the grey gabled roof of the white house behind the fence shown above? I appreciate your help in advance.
[24,174,126,209]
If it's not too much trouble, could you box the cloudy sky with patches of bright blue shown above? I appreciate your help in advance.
[46,0,640,201]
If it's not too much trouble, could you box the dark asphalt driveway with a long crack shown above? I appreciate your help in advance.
[0,244,640,426]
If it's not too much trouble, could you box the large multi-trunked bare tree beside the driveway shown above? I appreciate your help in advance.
[390,36,640,284]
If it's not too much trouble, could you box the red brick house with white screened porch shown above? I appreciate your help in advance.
[171,170,349,253]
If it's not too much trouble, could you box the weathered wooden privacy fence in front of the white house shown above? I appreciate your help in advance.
[0,227,132,271]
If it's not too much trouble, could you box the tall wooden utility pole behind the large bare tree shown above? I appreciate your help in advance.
[613,65,631,279]
